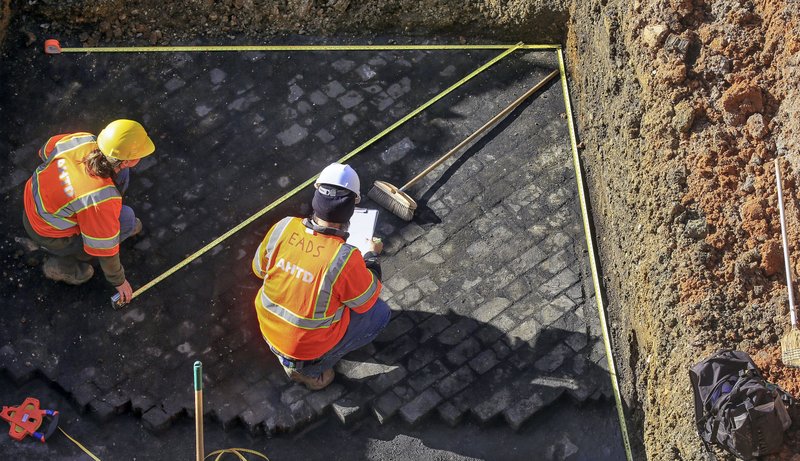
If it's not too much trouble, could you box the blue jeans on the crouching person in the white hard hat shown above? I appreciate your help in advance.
[280,298,392,378]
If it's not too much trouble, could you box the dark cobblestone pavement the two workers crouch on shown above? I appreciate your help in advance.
[0,37,617,448]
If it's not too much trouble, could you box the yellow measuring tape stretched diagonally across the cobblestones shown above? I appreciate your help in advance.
[133,43,523,298]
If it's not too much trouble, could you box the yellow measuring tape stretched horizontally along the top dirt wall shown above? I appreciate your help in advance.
[56,44,561,53]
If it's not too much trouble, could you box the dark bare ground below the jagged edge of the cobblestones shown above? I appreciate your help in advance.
[0,374,625,461]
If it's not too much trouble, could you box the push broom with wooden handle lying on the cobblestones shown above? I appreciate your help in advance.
[367,70,558,221]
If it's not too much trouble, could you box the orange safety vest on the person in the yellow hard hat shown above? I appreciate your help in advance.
[25,133,122,256]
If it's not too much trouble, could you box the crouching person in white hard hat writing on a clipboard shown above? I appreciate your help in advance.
[253,163,391,390]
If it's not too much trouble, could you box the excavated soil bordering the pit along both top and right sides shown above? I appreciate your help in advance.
[0,0,800,460]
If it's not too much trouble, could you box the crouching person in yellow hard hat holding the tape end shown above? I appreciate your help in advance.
[22,120,155,303]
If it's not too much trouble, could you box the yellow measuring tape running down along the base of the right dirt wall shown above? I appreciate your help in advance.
[556,49,633,461]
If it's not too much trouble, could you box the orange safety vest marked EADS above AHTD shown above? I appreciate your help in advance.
[253,217,382,360]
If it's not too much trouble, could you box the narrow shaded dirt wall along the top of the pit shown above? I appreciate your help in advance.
[3,0,567,46]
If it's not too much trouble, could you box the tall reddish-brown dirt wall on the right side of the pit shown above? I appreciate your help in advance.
[567,0,800,459]
